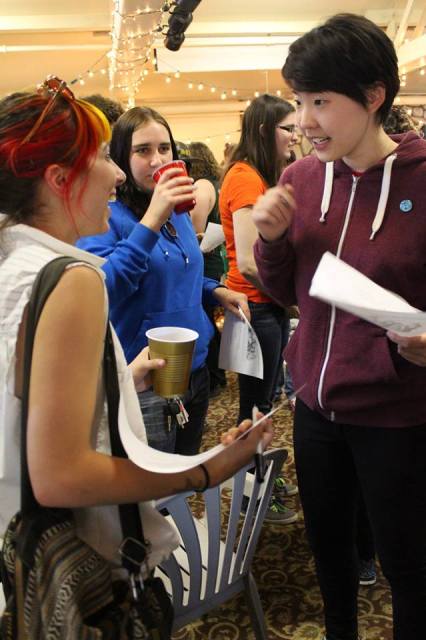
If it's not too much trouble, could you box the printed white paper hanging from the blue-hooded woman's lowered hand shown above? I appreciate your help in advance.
[219,310,263,380]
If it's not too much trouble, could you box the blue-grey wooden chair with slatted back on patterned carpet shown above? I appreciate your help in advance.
[157,449,287,640]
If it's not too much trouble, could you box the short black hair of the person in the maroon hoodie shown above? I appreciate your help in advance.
[282,13,399,123]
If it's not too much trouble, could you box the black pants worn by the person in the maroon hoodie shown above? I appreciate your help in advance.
[294,400,426,640]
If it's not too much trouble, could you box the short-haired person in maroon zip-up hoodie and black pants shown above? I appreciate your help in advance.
[253,14,426,640]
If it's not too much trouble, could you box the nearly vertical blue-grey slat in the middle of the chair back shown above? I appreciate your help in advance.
[203,486,221,599]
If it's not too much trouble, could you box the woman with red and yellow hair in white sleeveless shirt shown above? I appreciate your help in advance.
[0,79,270,596]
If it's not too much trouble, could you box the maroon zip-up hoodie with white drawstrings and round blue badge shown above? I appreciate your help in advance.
[255,132,426,427]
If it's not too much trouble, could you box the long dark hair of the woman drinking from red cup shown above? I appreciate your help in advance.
[110,107,179,217]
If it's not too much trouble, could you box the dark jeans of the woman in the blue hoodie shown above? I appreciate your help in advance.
[138,365,210,456]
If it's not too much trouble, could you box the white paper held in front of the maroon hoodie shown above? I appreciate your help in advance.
[309,252,426,336]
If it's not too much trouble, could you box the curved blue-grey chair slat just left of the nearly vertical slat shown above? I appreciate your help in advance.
[167,500,202,607]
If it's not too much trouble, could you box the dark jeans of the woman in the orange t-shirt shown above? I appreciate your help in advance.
[238,302,289,422]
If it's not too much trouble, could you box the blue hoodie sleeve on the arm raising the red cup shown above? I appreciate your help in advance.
[78,217,159,306]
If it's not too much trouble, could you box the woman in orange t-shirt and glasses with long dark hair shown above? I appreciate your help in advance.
[219,94,296,420]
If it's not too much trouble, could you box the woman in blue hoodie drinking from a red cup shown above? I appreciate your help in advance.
[80,107,249,455]
